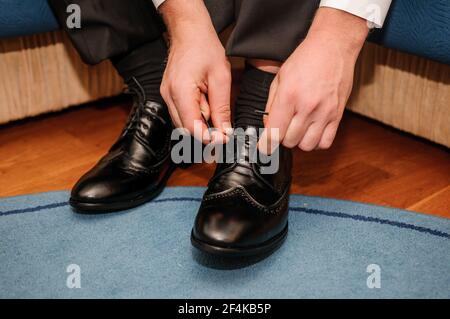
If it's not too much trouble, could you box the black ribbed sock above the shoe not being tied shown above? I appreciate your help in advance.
[111,38,167,104]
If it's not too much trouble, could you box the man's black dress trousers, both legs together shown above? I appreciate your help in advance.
[48,0,319,64]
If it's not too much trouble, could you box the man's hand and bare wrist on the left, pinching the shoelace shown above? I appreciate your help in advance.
[160,0,231,143]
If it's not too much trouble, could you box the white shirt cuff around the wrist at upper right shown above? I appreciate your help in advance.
[320,0,392,28]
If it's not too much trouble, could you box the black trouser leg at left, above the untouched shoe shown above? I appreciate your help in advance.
[48,0,164,64]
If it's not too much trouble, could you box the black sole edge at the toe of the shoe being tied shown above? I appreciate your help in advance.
[191,224,288,258]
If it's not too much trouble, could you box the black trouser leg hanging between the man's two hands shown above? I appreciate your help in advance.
[205,0,320,62]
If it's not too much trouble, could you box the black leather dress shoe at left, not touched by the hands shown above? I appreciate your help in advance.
[70,86,174,213]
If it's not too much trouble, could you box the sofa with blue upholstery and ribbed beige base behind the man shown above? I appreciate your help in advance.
[0,0,450,147]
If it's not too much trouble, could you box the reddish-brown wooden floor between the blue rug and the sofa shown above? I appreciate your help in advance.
[0,98,450,218]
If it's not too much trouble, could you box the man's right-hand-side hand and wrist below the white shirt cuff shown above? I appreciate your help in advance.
[259,8,368,153]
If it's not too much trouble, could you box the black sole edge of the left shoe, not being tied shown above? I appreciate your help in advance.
[69,166,175,215]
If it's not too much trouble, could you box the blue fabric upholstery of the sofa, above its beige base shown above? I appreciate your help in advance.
[0,0,450,64]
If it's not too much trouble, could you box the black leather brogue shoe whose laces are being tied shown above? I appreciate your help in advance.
[191,129,292,257]
